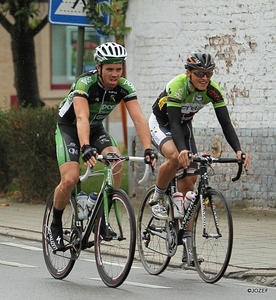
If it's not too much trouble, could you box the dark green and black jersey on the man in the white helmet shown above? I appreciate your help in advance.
[58,70,137,128]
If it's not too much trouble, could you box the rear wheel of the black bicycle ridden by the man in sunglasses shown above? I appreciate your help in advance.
[137,187,171,275]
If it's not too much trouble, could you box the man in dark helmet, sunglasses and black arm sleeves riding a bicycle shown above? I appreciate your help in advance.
[149,51,250,229]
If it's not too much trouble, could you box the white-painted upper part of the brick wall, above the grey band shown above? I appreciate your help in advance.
[126,0,276,128]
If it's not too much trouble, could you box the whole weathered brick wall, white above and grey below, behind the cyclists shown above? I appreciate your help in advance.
[126,0,276,208]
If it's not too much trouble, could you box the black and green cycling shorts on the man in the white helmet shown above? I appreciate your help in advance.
[55,124,118,166]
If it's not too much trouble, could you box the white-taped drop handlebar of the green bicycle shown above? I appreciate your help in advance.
[80,153,151,184]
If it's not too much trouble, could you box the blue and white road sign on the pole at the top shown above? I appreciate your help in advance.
[48,0,111,27]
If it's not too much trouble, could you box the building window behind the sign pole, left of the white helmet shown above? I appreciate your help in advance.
[51,25,105,89]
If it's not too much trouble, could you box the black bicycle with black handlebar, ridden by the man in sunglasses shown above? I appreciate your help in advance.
[137,155,245,283]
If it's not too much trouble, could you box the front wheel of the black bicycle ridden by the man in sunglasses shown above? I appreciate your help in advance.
[193,189,233,283]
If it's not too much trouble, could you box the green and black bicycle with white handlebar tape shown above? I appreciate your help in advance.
[42,153,144,287]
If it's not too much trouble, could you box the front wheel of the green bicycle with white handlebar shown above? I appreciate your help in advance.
[95,189,136,288]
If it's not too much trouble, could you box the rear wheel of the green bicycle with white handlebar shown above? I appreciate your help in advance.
[42,192,76,279]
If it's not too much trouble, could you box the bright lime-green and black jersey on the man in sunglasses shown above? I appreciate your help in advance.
[152,74,226,123]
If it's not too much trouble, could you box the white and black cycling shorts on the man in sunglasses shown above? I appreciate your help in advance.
[149,114,197,155]
